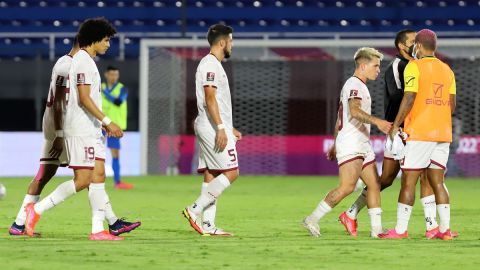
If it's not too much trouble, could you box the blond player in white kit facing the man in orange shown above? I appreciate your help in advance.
[303,48,392,238]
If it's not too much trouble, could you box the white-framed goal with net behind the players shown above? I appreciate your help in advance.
[140,39,480,176]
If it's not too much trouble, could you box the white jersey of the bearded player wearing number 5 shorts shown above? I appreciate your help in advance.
[195,54,233,130]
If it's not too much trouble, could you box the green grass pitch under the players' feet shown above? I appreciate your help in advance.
[0,176,480,270]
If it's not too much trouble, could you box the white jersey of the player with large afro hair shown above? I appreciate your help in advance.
[64,50,102,137]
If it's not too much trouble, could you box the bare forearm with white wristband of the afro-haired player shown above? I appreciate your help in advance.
[77,84,123,138]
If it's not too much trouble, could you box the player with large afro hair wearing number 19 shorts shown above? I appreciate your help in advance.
[25,18,140,240]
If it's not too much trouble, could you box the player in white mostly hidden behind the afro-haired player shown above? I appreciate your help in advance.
[8,37,80,235]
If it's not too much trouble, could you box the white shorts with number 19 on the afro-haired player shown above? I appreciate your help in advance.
[65,137,106,170]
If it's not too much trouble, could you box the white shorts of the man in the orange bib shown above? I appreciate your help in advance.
[400,141,450,171]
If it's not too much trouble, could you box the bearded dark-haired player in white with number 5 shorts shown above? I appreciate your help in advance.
[183,24,242,236]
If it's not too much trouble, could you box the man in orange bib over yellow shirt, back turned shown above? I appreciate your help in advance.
[380,29,456,240]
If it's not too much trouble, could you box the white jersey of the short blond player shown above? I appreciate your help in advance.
[335,77,372,152]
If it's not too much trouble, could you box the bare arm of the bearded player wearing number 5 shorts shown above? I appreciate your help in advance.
[203,85,228,152]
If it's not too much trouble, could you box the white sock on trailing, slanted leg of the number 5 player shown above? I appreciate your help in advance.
[189,174,230,215]
